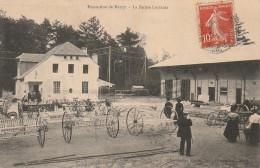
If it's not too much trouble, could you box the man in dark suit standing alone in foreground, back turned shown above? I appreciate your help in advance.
[177,113,192,156]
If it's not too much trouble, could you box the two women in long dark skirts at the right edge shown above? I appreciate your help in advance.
[224,105,260,145]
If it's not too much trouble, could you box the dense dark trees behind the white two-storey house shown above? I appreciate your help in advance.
[0,10,159,96]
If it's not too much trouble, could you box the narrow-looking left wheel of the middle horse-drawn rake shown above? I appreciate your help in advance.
[62,112,72,143]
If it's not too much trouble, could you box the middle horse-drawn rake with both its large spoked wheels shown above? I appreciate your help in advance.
[62,109,119,143]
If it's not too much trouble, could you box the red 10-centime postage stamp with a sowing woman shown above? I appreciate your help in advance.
[197,1,236,48]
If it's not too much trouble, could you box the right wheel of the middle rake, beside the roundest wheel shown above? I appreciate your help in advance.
[106,109,119,138]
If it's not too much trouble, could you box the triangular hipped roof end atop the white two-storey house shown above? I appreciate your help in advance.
[46,42,87,56]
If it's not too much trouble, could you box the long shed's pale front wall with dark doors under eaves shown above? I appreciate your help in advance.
[153,59,260,104]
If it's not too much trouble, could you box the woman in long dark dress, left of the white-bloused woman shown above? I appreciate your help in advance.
[224,106,239,142]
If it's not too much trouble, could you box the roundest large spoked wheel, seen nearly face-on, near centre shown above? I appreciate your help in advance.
[126,108,144,136]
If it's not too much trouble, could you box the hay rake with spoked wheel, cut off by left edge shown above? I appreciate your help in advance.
[0,117,45,147]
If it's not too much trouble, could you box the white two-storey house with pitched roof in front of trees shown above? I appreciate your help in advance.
[15,42,107,100]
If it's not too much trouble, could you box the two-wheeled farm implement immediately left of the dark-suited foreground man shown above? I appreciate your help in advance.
[126,108,177,136]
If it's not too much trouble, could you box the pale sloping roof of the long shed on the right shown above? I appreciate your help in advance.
[150,45,260,68]
